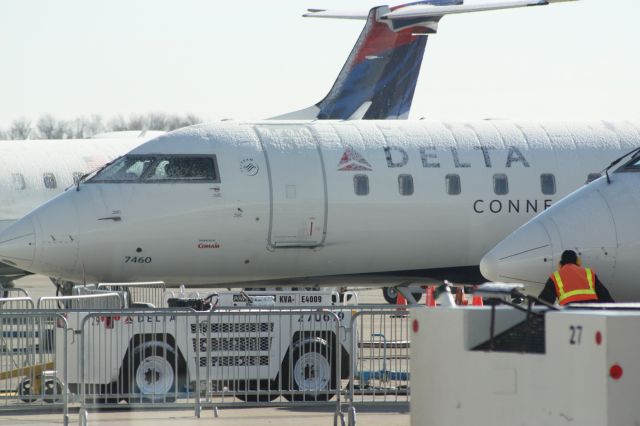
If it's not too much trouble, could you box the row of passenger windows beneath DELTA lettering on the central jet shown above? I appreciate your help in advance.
[353,173,600,195]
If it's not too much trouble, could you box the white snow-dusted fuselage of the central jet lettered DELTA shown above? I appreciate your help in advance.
[0,121,640,286]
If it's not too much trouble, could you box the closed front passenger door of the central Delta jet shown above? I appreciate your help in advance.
[256,125,327,249]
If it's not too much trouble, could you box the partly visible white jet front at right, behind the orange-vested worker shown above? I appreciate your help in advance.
[480,148,640,302]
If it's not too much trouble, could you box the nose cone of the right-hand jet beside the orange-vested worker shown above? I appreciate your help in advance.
[480,221,554,286]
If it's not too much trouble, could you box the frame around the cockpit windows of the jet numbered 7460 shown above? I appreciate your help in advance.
[87,154,220,184]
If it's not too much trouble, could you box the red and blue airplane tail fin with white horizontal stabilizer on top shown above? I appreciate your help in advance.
[274,0,573,120]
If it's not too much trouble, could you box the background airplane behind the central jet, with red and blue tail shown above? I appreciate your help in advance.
[0,0,470,288]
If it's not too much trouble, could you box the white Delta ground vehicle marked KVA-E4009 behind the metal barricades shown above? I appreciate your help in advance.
[56,291,353,403]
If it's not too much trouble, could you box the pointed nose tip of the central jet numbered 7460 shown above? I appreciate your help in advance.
[0,217,36,269]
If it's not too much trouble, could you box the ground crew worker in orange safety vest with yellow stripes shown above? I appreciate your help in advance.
[538,250,614,305]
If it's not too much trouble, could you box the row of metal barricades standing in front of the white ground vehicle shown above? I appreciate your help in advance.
[0,295,410,424]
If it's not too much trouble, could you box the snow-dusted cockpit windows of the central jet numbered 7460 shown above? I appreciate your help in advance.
[89,155,220,183]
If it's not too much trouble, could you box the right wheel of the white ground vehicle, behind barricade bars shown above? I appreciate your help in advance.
[282,337,337,401]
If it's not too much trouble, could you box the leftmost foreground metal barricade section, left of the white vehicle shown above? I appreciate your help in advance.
[0,310,69,425]
